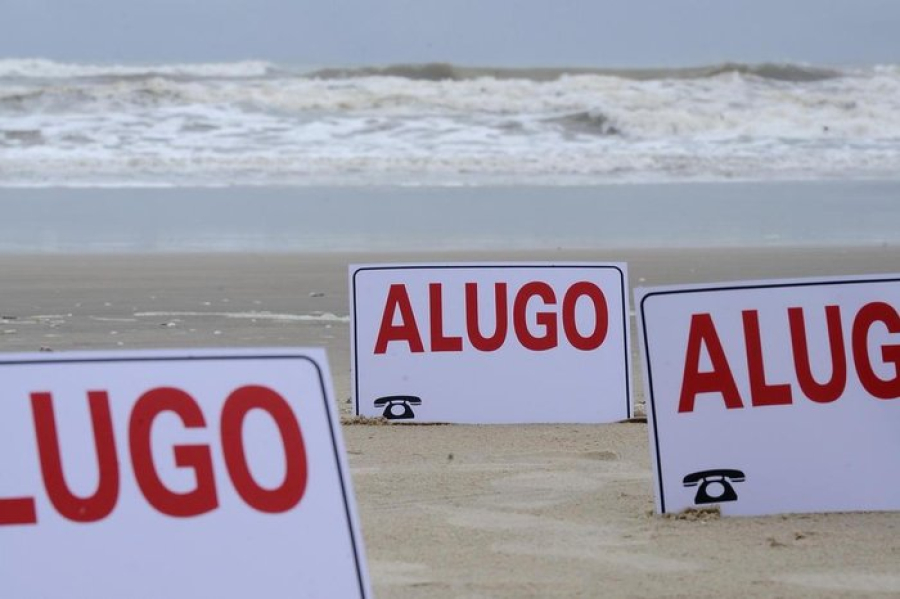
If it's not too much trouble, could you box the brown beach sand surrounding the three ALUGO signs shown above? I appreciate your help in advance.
[0,247,900,598]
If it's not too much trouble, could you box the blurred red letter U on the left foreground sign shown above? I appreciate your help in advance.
[31,391,119,522]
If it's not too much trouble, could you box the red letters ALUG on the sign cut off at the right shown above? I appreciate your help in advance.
[678,302,900,412]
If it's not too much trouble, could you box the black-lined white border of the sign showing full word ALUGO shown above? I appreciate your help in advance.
[350,262,634,420]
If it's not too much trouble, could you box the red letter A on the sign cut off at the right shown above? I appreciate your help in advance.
[678,314,744,412]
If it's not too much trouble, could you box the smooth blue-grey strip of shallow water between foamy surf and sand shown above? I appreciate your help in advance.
[0,180,900,254]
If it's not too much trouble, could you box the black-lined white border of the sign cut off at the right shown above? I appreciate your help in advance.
[634,274,900,515]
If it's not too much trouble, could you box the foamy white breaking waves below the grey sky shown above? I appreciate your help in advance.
[0,59,900,187]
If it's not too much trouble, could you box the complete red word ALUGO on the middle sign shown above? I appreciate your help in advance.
[375,281,609,354]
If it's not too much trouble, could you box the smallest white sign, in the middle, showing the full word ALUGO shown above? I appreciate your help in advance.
[350,263,631,423]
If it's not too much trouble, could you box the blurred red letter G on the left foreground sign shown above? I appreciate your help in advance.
[129,387,219,518]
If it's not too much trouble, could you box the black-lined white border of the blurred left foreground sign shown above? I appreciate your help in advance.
[0,347,371,599]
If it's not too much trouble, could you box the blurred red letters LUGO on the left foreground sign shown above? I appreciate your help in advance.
[0,385,307,525]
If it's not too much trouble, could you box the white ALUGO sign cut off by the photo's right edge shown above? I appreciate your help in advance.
[636,276,900,515]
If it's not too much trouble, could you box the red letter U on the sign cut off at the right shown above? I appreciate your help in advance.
[788,306,847,403]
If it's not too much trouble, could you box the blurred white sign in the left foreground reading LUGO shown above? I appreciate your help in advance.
[0,349,370,599]
